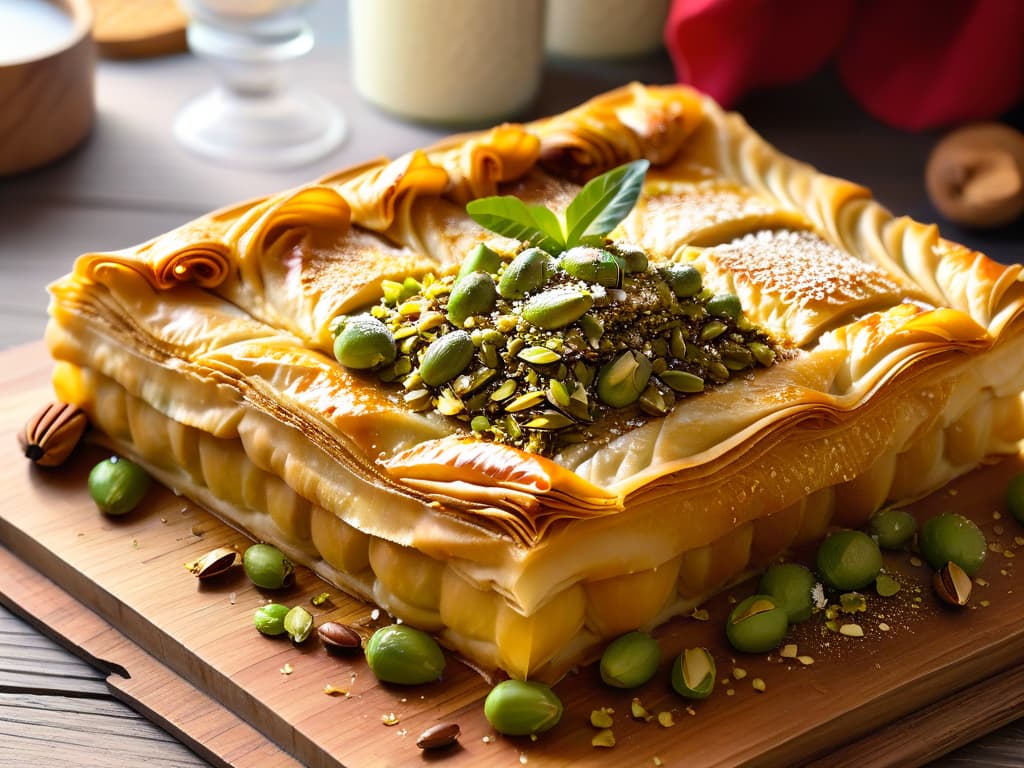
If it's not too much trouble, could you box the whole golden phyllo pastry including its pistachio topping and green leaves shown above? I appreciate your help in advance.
[47,86,1024,680]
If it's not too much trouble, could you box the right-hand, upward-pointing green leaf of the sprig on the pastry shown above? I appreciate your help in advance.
[565,160,650,248]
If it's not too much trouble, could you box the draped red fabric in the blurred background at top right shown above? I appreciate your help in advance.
[665,0,1024,130]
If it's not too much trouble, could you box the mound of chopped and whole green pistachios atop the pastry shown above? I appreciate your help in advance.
[335,241,779,454]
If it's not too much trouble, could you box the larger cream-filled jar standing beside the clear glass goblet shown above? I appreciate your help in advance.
[349,0,544,126]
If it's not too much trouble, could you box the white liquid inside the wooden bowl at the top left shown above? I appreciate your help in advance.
[0,0,75,65]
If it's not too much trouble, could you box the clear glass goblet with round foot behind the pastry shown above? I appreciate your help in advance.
[174,0,345,169]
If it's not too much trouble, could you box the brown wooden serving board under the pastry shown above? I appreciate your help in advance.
[0,345,1024,768]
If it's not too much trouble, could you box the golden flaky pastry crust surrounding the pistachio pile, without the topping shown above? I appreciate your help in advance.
[48,85,1024,676]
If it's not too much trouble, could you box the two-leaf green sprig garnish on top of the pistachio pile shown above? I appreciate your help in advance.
[466,160,650,255]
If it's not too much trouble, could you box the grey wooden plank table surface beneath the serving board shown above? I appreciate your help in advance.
[0,0,1024,768]
